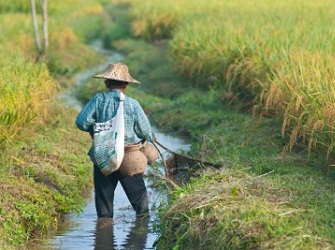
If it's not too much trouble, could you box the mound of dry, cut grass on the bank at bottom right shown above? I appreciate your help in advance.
[157,167,334,250]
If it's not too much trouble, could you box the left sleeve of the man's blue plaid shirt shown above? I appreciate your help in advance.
[76,95,97,132]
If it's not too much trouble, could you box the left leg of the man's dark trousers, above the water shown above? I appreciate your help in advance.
[94,165,118,218]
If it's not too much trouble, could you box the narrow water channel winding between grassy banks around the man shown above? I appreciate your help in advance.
[40,46,189,250]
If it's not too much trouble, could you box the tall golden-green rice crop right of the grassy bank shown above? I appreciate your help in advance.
[114,0,335,160]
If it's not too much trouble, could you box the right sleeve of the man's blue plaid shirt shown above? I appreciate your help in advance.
[134,101,153,142]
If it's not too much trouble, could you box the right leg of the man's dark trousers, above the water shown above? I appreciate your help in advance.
[119,174,149,215]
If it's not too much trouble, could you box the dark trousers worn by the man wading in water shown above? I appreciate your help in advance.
[94,165,148,218]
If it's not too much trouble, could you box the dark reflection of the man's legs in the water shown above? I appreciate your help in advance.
[94,217,149,250]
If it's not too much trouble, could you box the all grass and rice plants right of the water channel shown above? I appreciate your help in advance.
[96,0,335,249]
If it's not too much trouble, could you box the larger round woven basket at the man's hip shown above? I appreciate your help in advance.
[119,143,148,176]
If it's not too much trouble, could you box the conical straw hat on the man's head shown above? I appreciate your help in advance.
[94,63,140,84]
